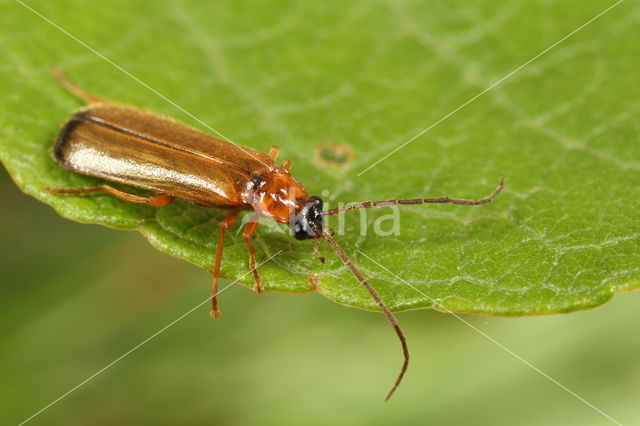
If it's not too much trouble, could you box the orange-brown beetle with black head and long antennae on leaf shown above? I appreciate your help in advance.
[47,69,504,401]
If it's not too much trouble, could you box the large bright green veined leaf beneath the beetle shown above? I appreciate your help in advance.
[0,1,640,315]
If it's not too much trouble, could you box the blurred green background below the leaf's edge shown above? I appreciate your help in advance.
[0,165,640,425]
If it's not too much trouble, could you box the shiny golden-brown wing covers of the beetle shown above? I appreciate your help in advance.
[54,104,275,207]
